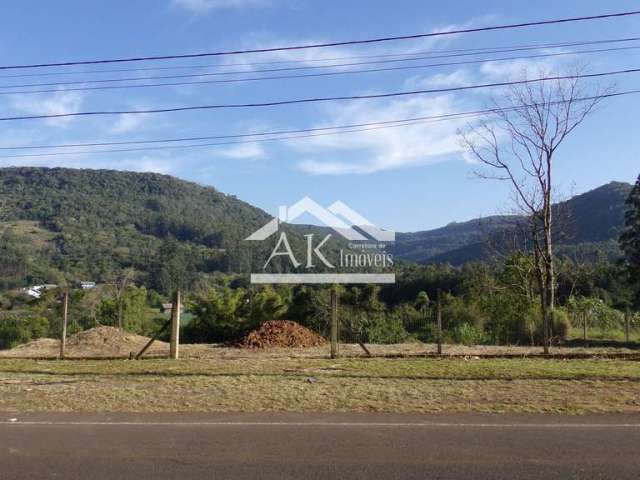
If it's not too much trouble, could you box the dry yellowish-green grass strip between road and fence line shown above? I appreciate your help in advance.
[0,355,640,414]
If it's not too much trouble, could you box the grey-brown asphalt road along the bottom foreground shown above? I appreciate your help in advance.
[0,414,640,480]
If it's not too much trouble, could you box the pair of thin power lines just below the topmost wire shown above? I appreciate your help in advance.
[0,37,640,81]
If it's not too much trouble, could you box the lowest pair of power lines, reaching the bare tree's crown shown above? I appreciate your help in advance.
[0,90,640,159]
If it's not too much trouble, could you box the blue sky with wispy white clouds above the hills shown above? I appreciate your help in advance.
[0,0,640,231]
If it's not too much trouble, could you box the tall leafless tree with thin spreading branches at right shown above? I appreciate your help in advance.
[462,69,608,353]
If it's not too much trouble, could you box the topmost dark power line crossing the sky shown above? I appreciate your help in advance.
[0,10,640,70]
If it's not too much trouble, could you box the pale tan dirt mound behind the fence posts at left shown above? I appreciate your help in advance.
[2,327,169,358]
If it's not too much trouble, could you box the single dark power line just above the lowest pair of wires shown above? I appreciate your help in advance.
[0,68,640,121]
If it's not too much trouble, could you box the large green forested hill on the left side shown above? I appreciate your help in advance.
[0,168,280,290]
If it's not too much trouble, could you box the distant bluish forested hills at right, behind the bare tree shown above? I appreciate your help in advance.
[395,182,632,265]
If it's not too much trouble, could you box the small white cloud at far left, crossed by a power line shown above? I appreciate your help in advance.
[10,90,84,127]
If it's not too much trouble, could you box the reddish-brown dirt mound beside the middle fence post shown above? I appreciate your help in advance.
[240,320,325,348]
